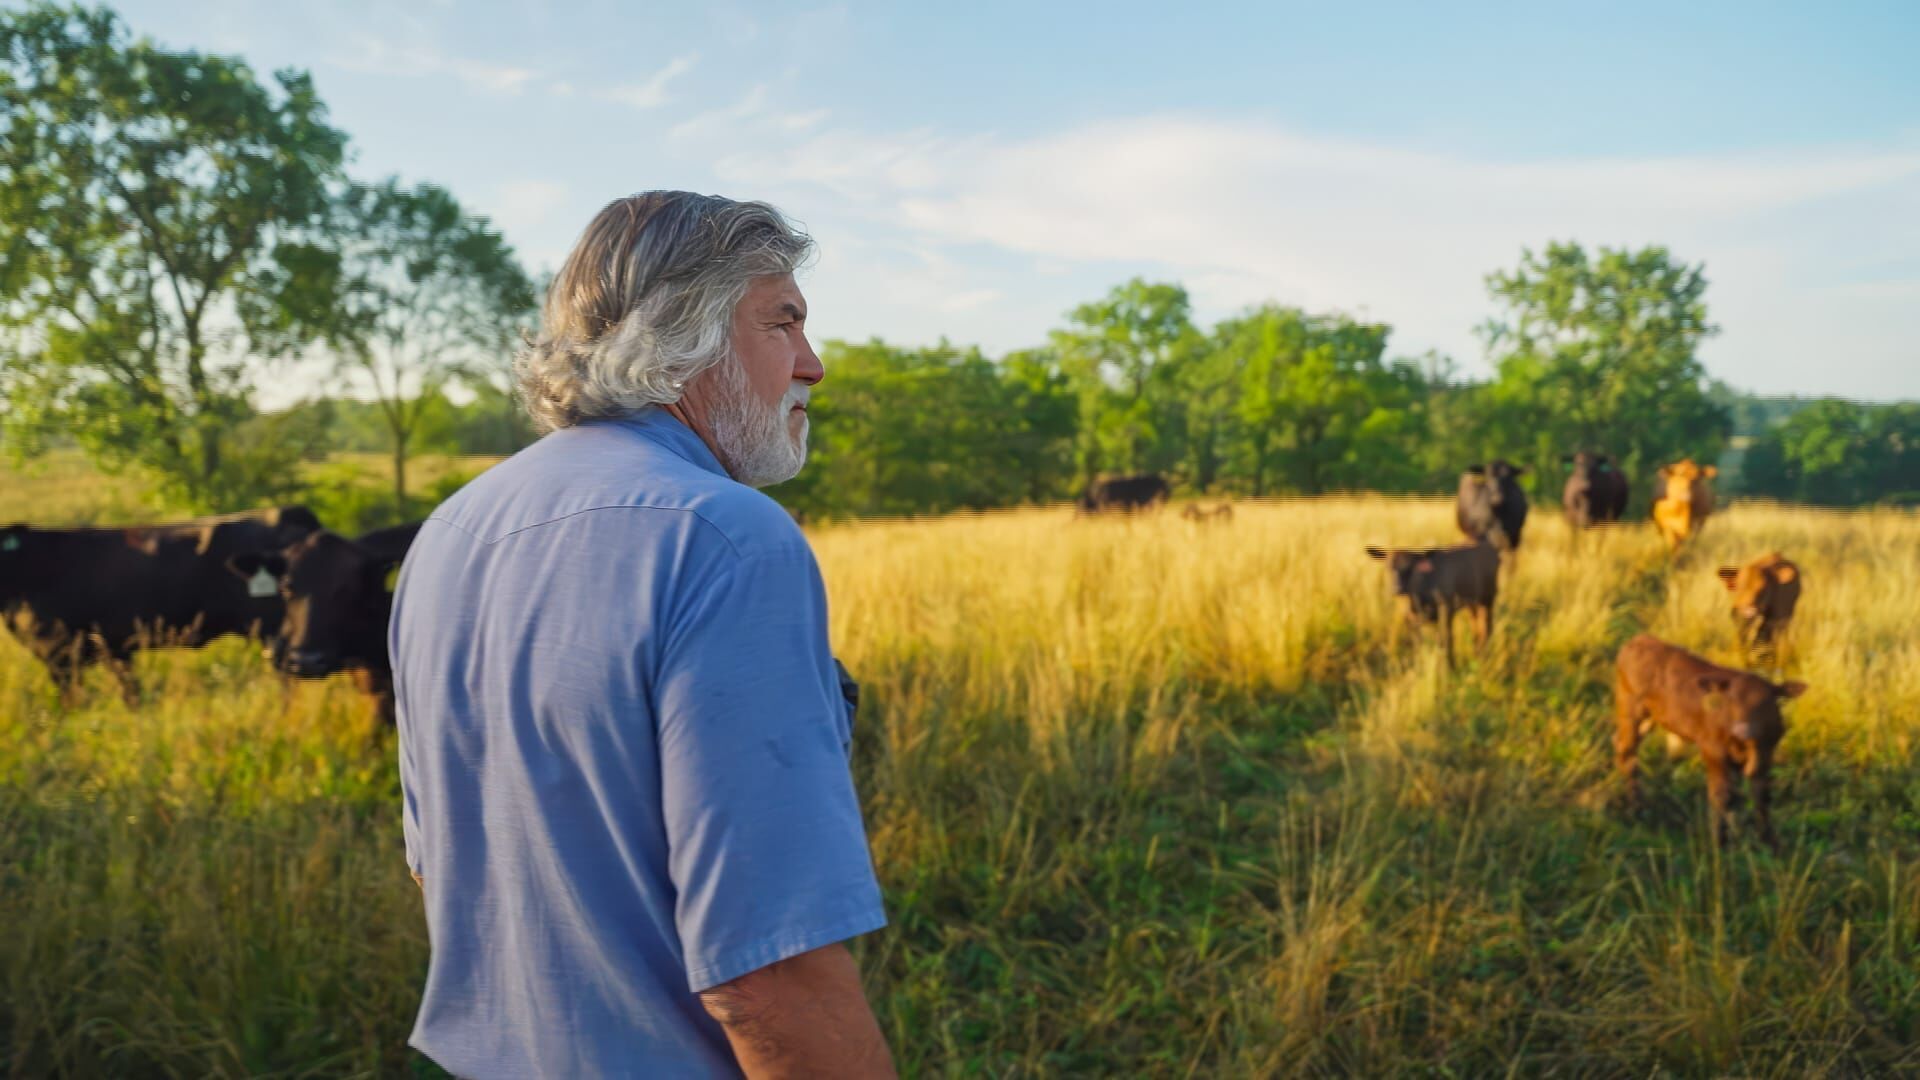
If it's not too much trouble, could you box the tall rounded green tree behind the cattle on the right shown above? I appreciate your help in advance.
[1471,244,1730,486]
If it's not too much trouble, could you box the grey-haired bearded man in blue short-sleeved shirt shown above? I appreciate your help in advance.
[390,192,893,1078]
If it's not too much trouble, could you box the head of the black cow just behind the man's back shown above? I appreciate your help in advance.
[228,532,392,678]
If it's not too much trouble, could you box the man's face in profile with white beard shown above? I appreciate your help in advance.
[682,275,826,488]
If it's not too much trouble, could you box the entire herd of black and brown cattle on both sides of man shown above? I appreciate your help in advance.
[0,454,1807,844]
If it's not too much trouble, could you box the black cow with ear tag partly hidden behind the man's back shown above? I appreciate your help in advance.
[228,521,422,724]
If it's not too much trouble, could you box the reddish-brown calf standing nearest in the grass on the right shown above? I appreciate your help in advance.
[1613,634,1807,847]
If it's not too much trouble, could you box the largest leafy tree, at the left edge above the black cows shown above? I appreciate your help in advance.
[0,4,346,507]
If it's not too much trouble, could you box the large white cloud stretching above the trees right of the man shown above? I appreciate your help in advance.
[716,115,1920,396]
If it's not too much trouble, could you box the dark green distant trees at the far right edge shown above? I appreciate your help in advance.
[1740,398,1920,505]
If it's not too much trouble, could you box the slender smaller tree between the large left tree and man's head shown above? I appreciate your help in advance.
[330,179,534,517]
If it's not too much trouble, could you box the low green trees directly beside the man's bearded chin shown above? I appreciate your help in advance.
[774,340,1073,517]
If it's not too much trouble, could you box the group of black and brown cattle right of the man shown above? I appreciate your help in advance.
[1079,452,1807,844]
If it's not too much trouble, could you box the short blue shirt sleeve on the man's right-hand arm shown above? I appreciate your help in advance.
[655,548,887,994]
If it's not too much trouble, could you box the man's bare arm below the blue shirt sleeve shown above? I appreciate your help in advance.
[701,944,897,1080]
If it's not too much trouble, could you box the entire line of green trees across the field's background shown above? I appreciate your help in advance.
[0,4,1920,523]
